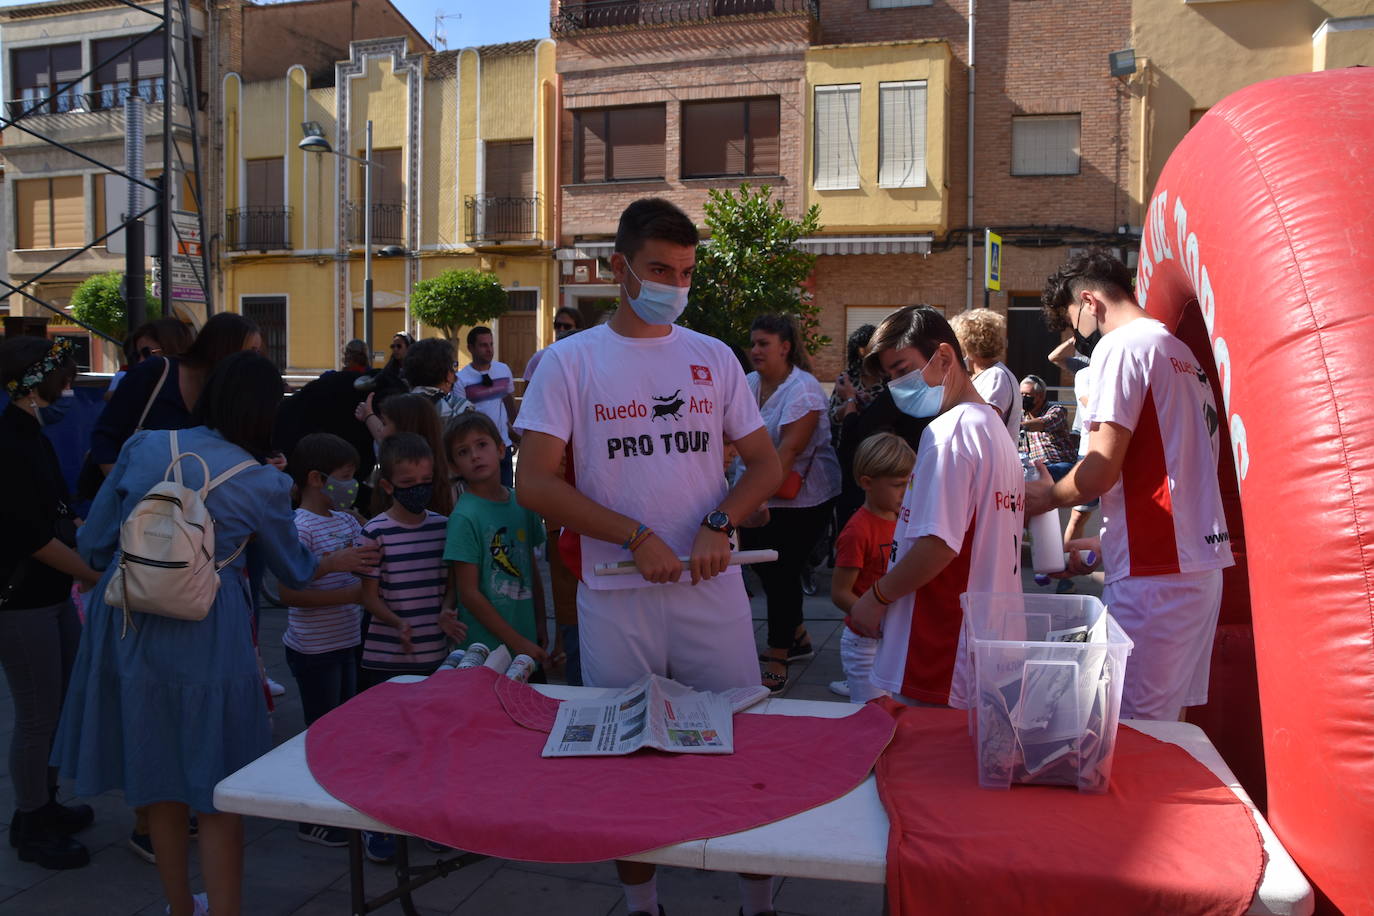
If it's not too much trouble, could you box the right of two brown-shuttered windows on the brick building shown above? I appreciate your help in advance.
[682,98,780,179]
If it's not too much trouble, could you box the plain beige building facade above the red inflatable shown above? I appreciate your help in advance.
[1129,0,1374,212]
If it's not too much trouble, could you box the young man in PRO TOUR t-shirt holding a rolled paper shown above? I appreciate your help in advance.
[515,199,782,916]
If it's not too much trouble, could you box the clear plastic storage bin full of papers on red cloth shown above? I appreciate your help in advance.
[959,592,1134,792]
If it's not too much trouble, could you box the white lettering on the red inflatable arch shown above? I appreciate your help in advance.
[1136,190,1250,481]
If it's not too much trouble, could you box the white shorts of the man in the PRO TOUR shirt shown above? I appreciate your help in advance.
[577,574,760,691]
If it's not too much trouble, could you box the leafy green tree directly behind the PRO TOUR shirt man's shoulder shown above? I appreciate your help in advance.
[682,184,830,353]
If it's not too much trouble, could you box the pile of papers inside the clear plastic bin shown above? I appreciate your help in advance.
[978,614,1112,787]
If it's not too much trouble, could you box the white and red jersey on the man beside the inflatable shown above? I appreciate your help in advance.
[1087,319,1234,582]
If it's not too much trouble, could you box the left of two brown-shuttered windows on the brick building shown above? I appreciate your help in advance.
[573,104,665,183]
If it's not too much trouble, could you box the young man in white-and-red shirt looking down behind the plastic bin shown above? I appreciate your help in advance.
[851,305,1025,707]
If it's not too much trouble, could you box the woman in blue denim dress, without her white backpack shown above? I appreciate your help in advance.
[54,353,363,916]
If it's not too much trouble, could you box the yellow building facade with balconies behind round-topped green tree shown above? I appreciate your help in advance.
[217,38,558,375]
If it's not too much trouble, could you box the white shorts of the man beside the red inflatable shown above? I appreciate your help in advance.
[1102,570,1221,722]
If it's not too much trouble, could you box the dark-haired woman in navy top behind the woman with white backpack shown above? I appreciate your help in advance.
[91,312,262,474]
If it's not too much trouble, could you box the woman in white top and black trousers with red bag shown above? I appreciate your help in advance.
[741,314,840,694]
